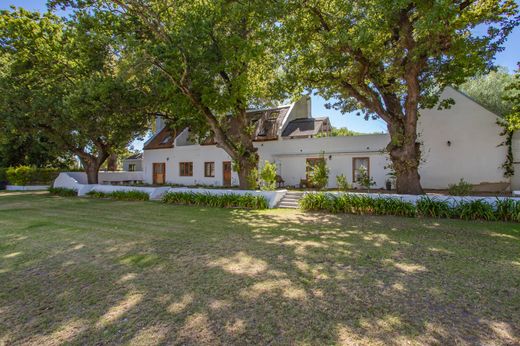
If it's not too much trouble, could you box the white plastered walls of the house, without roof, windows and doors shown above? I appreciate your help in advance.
[143,88,520,189]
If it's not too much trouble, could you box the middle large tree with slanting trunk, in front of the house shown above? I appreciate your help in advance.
[59,0,286,188]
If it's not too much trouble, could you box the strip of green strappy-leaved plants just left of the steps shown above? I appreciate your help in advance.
[162,192,269,209]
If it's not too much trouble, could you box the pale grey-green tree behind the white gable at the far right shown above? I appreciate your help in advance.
[459,68,514,117]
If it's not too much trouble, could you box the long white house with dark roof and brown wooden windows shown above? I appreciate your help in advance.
[143,88,520,191]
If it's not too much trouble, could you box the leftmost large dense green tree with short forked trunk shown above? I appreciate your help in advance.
[0,9,150,184]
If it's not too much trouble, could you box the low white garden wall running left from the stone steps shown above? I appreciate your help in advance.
[53,172,287,208]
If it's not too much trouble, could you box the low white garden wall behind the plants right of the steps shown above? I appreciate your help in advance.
[320,191,520,206]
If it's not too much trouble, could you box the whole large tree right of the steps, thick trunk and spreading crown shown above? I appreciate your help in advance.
[277,0,518,194]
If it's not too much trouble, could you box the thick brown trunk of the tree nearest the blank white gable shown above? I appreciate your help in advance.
[387,132,424,195]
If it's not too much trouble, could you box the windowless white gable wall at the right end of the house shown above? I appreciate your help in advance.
[419,88,508,188]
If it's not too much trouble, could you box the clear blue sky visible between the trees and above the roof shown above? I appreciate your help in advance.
[0,0,520,149]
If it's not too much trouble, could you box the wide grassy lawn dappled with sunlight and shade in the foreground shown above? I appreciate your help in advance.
[0,192,520,345]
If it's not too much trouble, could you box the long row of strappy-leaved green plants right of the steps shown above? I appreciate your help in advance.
[300,193,520,222]
